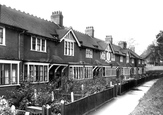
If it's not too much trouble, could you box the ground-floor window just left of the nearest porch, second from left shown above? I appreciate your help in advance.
[24,63,49,82]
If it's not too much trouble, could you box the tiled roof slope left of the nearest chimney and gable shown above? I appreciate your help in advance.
[0,5,59,39]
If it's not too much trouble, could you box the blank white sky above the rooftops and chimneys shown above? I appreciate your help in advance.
[0,0,163,55]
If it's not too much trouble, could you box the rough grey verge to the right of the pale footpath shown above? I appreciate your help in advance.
[130,78,163,115]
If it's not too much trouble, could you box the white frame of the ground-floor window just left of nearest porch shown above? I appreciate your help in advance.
[23,62,49,83]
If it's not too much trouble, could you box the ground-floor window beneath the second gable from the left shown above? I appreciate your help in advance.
[102,66,116,77]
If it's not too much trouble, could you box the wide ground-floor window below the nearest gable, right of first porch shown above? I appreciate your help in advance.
[69,65,93,80]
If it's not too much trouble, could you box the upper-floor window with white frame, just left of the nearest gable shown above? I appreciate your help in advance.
[31,37,46,52]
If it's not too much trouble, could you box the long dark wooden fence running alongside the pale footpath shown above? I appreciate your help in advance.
[25,72,163,115]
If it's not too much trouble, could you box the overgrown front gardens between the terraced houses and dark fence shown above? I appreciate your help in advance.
[0,75,121,115]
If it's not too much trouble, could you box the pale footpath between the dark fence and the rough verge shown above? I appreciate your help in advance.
[89,80,157,115]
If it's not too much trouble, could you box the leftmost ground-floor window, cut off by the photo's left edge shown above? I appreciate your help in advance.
[0,60,19,85]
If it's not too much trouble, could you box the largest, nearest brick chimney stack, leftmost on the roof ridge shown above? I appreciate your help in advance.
[51,11,63,27]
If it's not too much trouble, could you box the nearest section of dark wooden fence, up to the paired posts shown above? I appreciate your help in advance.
[62,88,114,115]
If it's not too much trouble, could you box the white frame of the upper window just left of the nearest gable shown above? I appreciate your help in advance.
[31,36,47,52]
